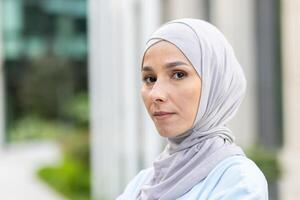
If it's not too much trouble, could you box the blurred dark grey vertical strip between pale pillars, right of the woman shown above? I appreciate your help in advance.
[256,0,283,150]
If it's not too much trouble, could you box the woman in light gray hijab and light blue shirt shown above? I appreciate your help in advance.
[118,19,268,200]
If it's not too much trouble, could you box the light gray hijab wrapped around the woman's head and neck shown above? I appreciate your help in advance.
[138,19,246,200]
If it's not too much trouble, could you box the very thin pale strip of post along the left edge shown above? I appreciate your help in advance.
[0,1,5,150]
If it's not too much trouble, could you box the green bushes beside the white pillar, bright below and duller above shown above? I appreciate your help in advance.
[38,130,90,200]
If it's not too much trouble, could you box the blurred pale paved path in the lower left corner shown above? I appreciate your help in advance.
[0,143,63,200]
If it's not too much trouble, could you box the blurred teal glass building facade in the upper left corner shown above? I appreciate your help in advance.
[1,0,87,61]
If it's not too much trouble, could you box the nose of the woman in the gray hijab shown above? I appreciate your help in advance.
[150,80,167,103]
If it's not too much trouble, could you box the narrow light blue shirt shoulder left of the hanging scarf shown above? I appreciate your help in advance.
[117,168,153,200]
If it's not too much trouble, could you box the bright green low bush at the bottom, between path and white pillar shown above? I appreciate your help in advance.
[38,157,91,200]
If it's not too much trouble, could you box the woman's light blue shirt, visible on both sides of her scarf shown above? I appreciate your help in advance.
[117,156,268,200]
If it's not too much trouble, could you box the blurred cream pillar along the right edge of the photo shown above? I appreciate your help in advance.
[280,0,300,200]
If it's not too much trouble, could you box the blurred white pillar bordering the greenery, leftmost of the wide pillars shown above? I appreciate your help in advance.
[88,0,125,200]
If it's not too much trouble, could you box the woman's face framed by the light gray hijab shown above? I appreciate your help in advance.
[141,41,201,137]
